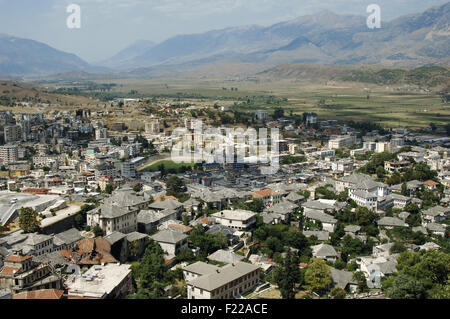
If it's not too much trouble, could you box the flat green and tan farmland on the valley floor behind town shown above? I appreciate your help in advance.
[92,79,450,128]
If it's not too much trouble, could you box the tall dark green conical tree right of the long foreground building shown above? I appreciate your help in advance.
[273,250,301,299]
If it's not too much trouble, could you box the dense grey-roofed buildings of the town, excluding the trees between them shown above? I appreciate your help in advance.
[0,110,450,299]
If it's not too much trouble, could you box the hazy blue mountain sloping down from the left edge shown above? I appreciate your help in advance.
[0,35,106,76]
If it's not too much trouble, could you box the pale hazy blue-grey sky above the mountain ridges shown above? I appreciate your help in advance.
[0,0,448,62]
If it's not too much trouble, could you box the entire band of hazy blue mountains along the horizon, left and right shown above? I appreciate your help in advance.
[0,2,450,76]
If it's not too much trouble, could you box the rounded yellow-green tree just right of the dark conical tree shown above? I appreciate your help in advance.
[305,258,331,295]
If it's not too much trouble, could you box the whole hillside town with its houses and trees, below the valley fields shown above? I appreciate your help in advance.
[0,99,450,299]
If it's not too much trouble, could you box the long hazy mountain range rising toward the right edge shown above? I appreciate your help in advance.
[111,2,450,73]
